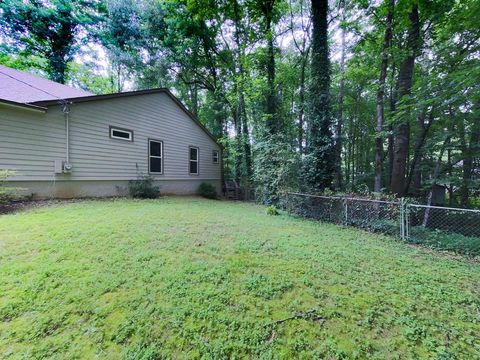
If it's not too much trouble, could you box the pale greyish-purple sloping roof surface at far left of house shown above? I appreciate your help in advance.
[0,65,93,103]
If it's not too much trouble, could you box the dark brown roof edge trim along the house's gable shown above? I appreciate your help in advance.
[29,88,223,149]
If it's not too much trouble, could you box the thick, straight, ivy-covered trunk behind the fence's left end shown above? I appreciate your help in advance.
[305,0,335,192]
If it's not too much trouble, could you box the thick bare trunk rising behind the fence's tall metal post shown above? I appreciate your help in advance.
[390,4,420,197]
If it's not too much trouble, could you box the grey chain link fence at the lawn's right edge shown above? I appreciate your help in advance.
[282,192,480,256]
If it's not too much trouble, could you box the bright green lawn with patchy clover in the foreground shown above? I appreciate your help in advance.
[0,198,480,359]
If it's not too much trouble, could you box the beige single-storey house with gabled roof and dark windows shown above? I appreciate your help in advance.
[0,66,222,198]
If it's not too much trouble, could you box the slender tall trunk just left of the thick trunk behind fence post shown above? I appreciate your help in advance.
[373,0,395,192]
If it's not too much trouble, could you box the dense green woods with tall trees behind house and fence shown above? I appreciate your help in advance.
[0,0,480,207]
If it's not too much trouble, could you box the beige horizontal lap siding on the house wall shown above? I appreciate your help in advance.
[0,93,221,180]
